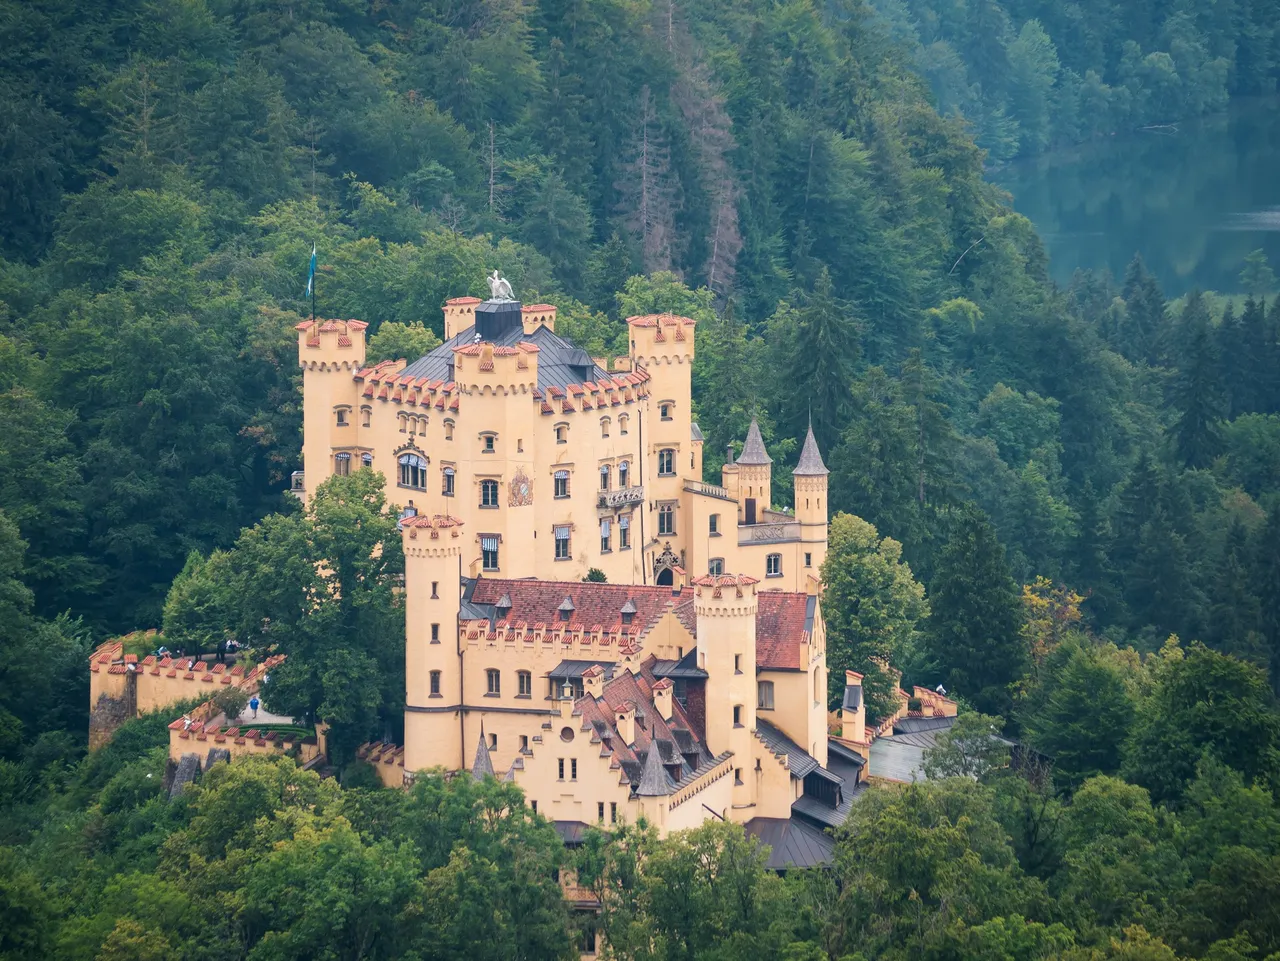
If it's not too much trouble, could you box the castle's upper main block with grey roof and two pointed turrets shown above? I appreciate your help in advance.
[293,297,827,594]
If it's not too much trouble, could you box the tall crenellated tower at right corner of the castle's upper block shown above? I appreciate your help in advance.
[627,314,701,584]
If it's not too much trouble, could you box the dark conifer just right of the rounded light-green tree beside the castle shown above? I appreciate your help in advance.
[925,504,1028,717]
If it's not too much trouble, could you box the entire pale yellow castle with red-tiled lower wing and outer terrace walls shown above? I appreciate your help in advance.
[91,281,956,868]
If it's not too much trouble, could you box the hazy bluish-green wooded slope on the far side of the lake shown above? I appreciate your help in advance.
[872,0,1280,161]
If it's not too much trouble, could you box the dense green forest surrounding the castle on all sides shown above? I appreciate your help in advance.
[0,0,1280,961]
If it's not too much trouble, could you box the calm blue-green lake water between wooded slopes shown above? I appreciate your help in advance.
[991,97,1280,297]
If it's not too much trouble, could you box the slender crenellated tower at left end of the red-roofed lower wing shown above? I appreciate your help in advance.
[401,514,466,774]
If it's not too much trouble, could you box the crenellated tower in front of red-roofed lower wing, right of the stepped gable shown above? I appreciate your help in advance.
[694,575,759,822]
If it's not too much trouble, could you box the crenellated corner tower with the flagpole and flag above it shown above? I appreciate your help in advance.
[302,320,369,503]
